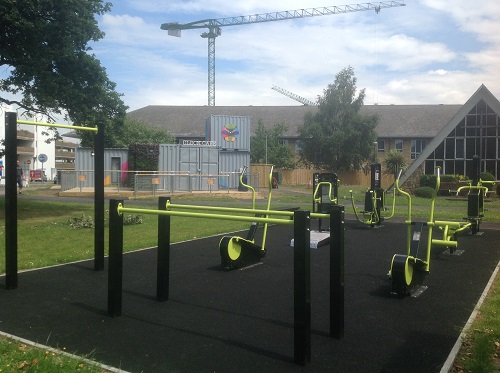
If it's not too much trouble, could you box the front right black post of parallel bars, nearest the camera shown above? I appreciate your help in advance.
[293,210,311,365]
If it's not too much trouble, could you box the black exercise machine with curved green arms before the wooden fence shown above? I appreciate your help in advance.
[349,163,396,228]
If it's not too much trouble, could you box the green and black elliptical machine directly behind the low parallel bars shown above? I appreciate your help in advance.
[219,167,273,270]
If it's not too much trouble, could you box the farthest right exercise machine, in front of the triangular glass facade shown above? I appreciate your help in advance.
[456,155,492,234]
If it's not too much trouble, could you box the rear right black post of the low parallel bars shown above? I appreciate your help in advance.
[330,205,345,338]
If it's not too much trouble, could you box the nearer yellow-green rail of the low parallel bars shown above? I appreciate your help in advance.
[117,206,293,225]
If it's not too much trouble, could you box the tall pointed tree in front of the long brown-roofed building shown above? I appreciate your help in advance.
[299,67,378,171]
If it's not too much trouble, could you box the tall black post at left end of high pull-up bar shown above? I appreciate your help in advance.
[5,112,17,289]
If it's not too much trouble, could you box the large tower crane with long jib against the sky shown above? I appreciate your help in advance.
[161,1,405,106]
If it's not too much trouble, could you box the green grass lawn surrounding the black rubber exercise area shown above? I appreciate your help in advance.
[0,186,500,372]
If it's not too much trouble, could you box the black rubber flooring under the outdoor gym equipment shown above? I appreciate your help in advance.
[0,221,500,373]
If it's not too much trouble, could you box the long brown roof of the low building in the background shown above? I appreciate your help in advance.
[128,105,462,138]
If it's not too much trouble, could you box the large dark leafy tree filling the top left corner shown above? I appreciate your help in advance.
[0,0,126,146]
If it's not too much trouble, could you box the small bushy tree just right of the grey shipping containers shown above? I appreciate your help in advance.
[250,120,295,169]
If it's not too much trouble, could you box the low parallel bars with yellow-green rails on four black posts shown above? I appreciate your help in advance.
[108,197,344,365]
